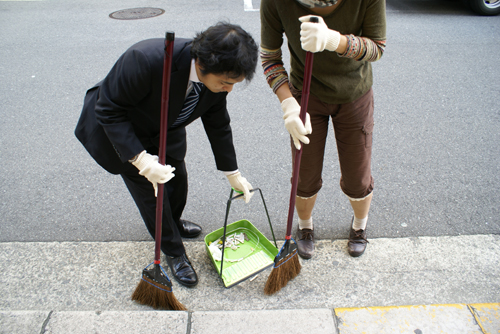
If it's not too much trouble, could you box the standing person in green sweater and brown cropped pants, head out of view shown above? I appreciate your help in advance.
[260,0,386,259]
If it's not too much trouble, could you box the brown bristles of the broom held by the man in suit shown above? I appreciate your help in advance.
[132,275,187,311]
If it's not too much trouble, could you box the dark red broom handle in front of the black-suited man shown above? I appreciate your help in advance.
[154,32,175,264]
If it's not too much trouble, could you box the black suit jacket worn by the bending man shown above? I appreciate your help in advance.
[75,38,238,174]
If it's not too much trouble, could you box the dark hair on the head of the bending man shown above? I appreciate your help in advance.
[191,22,258,81]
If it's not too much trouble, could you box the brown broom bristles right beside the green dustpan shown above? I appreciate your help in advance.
[264,250,302,295]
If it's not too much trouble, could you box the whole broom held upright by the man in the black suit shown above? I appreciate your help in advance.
[132,32,186,311]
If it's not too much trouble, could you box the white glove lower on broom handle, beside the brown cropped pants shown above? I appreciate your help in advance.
[281,97,312,150]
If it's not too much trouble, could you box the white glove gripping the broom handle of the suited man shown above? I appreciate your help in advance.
[131,151,175,196]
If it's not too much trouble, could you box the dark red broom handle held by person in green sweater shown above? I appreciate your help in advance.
[286,16,318,240]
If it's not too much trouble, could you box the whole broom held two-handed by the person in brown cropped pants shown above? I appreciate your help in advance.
[264,17,318,295]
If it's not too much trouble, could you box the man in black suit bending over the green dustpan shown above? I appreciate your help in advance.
[75,23,258,287]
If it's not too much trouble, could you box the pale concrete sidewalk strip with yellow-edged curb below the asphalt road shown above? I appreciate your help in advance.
[0,235,500,334]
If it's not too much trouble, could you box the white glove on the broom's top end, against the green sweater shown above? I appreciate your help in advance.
[299,15,340,52]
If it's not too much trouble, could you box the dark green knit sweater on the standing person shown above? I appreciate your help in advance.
[260,0,386,104]
